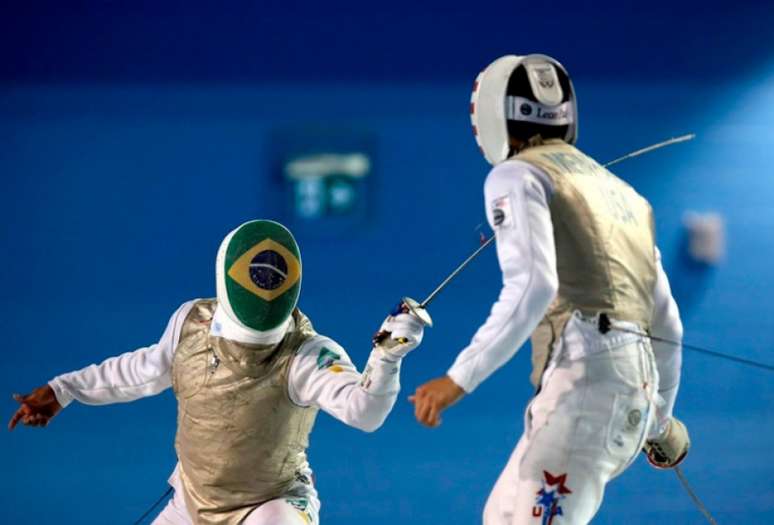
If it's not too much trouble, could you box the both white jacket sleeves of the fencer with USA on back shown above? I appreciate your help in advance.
[448,160,683,420]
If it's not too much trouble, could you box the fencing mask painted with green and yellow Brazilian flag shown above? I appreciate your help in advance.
[217,220,301,331]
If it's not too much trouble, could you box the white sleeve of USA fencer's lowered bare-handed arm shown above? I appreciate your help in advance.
[447,160,559,393]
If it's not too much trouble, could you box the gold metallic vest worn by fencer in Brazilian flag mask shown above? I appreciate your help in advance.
[172,299,317,524]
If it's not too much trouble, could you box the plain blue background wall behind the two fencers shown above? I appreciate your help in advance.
[0,2,774,524]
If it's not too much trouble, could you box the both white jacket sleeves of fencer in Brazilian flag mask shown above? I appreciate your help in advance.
[49,300,401,432]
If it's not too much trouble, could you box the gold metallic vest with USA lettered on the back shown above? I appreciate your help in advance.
[515,140,656,386]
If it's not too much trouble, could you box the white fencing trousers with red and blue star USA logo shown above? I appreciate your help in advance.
[484,312,658,525]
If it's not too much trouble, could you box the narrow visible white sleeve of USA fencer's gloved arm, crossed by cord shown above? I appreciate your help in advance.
[650,249,683,432]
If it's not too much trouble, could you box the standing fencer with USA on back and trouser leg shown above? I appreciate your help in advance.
[411,55,689,525]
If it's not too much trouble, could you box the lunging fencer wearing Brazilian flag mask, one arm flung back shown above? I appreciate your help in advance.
[9,220,423,525]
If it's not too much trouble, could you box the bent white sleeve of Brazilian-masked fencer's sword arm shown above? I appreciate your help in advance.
[288,336,401,432]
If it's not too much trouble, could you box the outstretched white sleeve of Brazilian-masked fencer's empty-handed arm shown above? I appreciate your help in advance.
[48,301,195,407]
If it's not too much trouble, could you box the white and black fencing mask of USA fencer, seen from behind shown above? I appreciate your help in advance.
[470,55,578,165]
